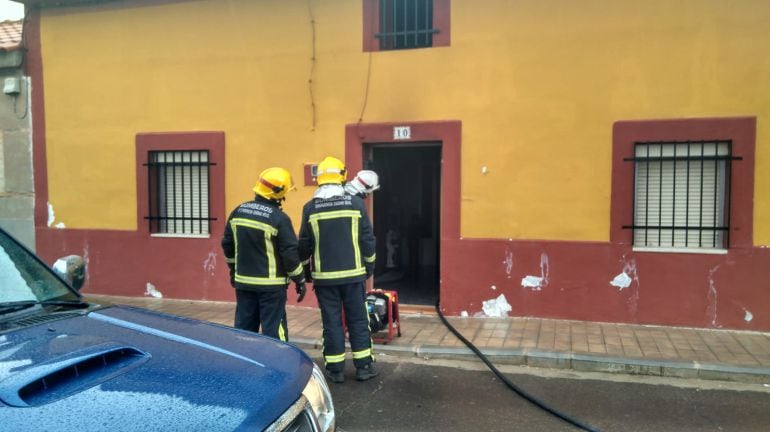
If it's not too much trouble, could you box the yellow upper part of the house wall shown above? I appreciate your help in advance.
[42,0,770,245]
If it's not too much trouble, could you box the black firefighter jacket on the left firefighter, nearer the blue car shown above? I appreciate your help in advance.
[222,196,302,291]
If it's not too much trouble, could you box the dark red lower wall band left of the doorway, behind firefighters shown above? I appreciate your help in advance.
[36,228,317,307]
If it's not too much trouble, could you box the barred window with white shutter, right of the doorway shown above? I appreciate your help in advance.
[623,140,742,249]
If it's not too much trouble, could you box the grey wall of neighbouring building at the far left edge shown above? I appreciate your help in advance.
[0,51,35,250]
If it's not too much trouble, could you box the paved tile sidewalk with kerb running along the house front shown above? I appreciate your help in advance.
[86,295,770,385]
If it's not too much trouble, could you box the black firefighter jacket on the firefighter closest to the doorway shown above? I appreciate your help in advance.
[299,194,375,286]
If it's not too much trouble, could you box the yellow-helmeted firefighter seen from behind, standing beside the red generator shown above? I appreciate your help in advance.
[299,157,378,383]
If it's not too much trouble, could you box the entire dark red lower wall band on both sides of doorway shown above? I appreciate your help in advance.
[37,228,770,331]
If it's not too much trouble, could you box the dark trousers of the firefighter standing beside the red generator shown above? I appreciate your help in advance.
[315,282,374,372]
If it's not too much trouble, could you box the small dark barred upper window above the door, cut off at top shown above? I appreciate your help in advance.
[374,0,438,50]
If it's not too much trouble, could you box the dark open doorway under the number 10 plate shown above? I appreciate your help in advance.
[364,142,441,305]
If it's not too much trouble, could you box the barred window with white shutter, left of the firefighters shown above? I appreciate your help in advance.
[144,150,216,235]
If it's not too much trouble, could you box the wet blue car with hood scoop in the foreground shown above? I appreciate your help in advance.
[0,229,335,432]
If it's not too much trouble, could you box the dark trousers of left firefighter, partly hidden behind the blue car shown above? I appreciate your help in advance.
[235,289,289,341]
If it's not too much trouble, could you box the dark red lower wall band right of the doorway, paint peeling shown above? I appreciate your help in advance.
[441,239,770,331]
